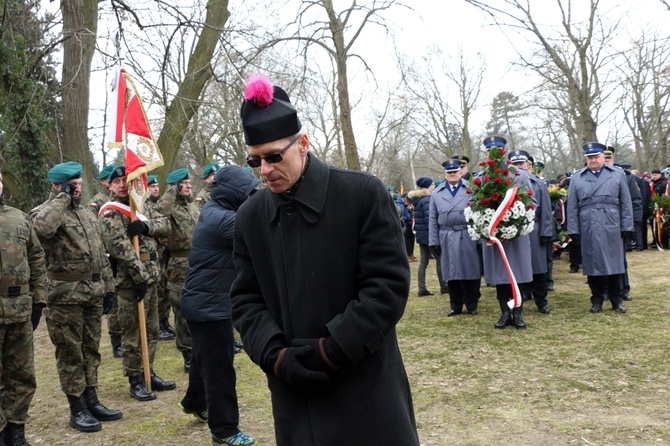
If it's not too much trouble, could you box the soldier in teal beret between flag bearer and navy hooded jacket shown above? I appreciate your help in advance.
[158,169,200,372]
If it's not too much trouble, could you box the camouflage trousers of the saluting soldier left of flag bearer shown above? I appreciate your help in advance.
[44,302,102,396]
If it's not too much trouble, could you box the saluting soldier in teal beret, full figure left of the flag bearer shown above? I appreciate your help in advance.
[30,162,123,432]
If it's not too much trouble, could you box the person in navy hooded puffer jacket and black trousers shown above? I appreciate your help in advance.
[179,166,260,445]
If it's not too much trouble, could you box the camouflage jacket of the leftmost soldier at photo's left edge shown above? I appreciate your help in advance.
[0,197,47,325]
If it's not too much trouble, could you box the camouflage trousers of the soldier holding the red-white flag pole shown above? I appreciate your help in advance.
[116,285,158,376]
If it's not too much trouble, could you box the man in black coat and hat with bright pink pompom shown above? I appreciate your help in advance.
[231,77,419,446]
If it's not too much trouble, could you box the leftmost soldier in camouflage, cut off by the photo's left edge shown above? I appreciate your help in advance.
[0,173,47,446]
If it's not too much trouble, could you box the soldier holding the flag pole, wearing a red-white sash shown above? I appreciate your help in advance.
[99,166,177,401]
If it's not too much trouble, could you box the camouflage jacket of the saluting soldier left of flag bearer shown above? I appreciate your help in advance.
[30,190,114,304]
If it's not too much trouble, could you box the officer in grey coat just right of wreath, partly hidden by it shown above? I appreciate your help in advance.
[507,150,554,314]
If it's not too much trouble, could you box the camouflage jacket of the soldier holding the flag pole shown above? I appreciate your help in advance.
[98,193,171,288]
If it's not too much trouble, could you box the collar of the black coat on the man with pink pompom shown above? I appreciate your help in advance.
[265,152,330,224]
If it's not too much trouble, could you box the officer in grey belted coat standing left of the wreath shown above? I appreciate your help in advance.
[428,159,481,317]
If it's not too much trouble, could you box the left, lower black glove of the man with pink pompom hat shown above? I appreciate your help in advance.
[274,345,331,390]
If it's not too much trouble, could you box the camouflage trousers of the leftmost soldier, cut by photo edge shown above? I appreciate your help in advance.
[0,321,36,430]
